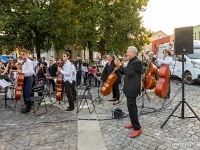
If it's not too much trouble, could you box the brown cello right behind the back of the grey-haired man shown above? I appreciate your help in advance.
[142,62,158,89]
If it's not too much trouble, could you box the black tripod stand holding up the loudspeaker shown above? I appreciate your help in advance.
[160,54,200,129]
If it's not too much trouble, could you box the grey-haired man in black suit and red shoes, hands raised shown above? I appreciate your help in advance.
[115,46,142,138]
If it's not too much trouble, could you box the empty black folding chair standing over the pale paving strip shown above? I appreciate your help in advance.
[76,85,96,114]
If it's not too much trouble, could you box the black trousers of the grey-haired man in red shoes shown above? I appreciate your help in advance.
[127,97,141,130]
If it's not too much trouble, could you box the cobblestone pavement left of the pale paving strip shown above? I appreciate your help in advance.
[0,93,78,150]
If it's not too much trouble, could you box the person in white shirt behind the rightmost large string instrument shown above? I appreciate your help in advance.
[157,49,173,98]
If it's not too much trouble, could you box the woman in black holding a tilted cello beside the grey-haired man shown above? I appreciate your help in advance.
[101,54,121,105]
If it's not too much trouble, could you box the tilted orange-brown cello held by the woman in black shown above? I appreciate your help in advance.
[100,67,118,96]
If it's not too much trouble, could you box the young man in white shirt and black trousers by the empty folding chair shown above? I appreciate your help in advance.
[58,52,74,111]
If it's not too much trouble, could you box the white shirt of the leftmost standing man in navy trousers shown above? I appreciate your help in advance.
[22,58,34,77]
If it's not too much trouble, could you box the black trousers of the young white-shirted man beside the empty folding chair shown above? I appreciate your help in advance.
[65,81,74,109]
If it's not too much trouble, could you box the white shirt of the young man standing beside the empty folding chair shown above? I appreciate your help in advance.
[60,60,72,83]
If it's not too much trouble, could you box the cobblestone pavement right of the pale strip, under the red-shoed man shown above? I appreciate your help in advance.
[99,80,200,150]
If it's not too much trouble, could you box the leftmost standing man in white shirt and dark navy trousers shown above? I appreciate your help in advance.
[17,49,34,113]
